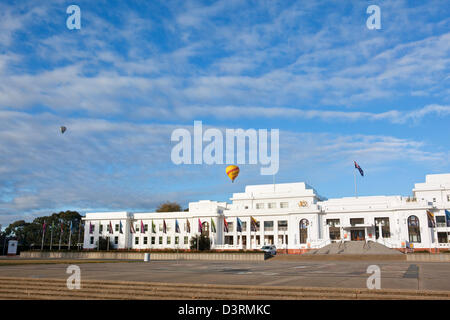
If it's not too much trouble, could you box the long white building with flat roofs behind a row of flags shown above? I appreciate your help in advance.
[83,174,450,253]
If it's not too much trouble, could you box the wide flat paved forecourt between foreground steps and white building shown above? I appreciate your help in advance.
[0,260,450,290]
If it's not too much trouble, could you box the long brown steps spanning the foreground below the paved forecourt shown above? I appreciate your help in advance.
[0,277,450,300]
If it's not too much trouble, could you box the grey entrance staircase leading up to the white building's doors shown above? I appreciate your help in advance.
[305,241,403,255]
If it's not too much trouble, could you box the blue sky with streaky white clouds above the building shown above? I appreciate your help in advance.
[0,0,450,226]
